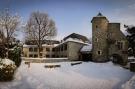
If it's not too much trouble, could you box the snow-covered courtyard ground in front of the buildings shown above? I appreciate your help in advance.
[0,62,134,89]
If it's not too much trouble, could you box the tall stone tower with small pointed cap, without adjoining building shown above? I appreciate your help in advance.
[91,13,109,62]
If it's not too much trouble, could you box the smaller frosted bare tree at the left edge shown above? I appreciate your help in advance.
[0,9,20,57]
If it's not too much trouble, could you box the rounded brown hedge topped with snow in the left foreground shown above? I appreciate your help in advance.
[0,59,16,81]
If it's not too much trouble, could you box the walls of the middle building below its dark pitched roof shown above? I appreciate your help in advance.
[54,41,86,61]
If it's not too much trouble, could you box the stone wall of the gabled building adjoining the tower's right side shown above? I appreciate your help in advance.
[108,23,128,63]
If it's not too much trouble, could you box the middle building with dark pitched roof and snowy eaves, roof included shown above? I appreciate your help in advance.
[54,33,89,61]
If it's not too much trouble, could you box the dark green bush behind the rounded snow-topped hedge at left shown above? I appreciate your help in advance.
[8,46,21,67]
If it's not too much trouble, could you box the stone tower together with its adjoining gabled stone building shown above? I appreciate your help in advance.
[91,13,128,63]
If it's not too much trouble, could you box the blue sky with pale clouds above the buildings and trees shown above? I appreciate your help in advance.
[0,0,135,40]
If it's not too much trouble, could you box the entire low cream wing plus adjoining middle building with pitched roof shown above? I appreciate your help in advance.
[23,33,89,60]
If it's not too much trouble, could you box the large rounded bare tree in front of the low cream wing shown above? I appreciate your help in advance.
[26,11,56,57]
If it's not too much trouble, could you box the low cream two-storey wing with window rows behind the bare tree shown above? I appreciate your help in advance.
[23,40,60,58]
